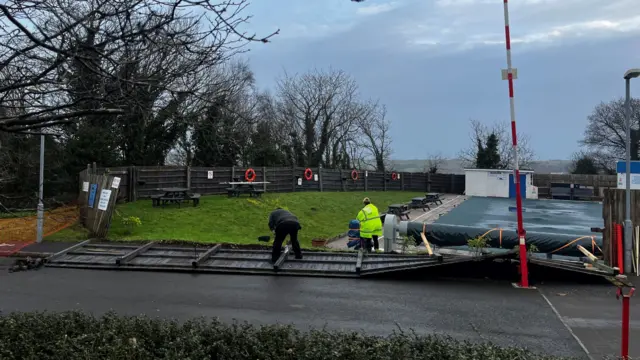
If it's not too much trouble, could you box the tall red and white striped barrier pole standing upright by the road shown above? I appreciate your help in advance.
[503,0,529,288]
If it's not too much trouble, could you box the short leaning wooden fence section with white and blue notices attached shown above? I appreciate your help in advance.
[78,169,122,238]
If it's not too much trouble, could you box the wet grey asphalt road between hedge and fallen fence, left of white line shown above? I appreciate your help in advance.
[0,264,584,357]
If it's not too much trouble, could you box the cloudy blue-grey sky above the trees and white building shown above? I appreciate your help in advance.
[236,0,640,160]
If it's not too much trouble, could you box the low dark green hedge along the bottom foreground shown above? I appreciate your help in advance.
[0,312,572,360]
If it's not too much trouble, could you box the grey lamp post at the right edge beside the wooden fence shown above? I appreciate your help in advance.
[620,69,640,274]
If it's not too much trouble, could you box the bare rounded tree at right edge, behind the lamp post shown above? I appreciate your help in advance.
[581,99,640,174]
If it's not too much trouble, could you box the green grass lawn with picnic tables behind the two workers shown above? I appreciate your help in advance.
[47,191,424,247]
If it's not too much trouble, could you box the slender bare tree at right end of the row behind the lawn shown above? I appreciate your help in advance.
[358,102,392,171]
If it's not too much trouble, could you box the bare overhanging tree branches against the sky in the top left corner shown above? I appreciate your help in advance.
[0,0,277,132]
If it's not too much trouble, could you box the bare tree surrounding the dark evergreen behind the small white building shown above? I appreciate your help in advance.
[458,120,535,169]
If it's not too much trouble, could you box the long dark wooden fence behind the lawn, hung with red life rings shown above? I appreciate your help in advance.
[84,166,464,201]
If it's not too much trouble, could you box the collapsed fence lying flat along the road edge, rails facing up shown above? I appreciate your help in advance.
[46,240,512,277]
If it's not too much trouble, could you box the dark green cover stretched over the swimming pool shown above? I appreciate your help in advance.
[408,197,604,256]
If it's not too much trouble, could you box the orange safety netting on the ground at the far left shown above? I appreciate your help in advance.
[0,206,78,256]
